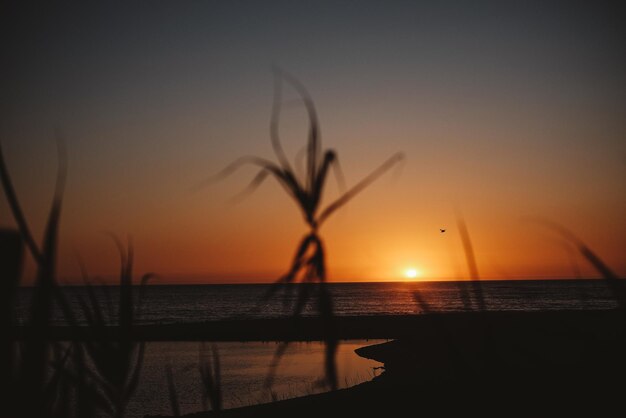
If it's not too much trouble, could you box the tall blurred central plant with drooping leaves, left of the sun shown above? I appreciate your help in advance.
[204,69,404,389]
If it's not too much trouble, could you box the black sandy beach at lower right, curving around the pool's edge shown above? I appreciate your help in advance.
[144,310,626,418]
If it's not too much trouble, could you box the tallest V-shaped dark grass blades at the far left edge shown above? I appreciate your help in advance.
[0,139,69,417]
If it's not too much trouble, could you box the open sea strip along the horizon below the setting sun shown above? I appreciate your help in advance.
[16,280,617,324]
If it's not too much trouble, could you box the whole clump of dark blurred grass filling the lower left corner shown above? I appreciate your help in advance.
[0,138,152,418]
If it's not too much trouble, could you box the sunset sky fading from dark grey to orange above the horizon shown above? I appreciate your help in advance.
[0,1,626,283]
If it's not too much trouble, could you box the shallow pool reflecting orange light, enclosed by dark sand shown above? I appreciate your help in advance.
[125,340,382,418]
